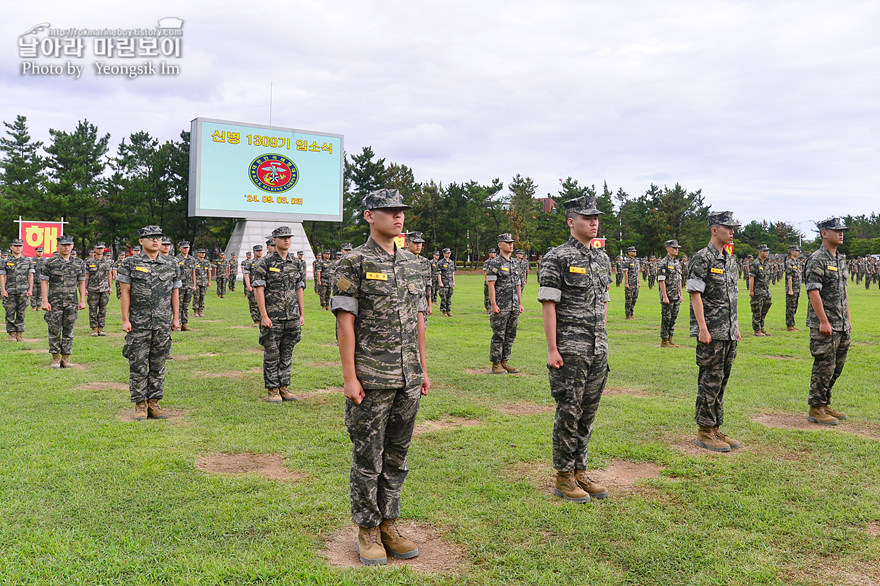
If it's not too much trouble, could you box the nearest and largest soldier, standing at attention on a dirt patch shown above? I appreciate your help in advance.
[330,189,431,565]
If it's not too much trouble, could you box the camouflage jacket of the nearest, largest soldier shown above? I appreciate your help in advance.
[330,238,427,390]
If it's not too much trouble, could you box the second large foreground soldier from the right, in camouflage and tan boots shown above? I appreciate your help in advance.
[687,212,740,452]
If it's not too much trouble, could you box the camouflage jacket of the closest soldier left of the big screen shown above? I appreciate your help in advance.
[118,252,182,330]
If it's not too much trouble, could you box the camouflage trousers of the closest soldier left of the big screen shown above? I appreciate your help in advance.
[122,329,171,403]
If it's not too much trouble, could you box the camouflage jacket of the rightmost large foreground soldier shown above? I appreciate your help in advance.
[804,245,849,332]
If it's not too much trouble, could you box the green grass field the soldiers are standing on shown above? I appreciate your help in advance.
[0,275,880,585]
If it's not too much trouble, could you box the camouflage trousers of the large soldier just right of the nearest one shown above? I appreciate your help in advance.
[549,353,608,472]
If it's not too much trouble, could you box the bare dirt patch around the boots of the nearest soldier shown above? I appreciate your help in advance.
[321,521,468,574]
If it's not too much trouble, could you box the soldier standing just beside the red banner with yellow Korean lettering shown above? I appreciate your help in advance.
[40,236,88,368]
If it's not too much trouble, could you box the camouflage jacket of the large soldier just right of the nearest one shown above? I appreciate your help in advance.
[538,238,612,356]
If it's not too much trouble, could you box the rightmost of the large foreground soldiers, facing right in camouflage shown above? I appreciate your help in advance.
[804,218,852,425]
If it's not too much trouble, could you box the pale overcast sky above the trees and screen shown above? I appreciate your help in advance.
[0,0,880,230]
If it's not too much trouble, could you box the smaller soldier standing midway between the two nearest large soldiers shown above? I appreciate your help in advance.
[486,233,525,374]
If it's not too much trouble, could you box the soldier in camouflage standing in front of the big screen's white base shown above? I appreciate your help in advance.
[251,226,306,403]
